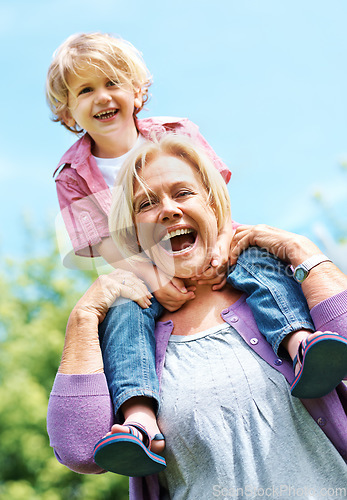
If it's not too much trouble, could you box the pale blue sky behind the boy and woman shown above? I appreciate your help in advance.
[0,0,347,270]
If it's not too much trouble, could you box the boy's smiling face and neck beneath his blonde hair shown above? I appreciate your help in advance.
[63,65,142,157]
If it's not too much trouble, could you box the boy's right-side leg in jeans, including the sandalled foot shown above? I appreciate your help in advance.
[228,247,347,398]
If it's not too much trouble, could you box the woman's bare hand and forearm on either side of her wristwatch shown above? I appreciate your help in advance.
[230,224,347,309]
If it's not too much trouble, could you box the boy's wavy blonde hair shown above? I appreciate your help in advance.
[46,33,152,134]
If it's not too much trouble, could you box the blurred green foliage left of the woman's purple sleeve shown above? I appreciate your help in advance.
[0,236,128,500]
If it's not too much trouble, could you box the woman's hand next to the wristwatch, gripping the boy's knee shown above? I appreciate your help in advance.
[229,224,322,267]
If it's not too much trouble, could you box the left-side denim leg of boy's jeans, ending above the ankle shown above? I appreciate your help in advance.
[99,297,163,420]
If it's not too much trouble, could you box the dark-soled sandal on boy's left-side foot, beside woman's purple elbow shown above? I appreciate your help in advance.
[94,422,166,477]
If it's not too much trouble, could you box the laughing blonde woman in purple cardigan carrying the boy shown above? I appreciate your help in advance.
[48,136,347,499]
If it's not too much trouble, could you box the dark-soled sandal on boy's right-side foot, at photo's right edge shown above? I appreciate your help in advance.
[290,332,347,399]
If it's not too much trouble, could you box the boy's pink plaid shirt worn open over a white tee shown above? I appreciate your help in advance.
[53,117,231,257]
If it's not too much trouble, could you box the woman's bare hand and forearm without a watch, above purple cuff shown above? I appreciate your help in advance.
[59,270,151,375]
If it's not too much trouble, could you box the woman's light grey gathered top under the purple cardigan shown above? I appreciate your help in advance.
[158,325,347,500]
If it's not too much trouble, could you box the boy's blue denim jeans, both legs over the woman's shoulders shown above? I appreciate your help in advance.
[99,247,314,416]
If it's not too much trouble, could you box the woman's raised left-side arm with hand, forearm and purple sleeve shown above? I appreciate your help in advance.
[47,271,151,474]
